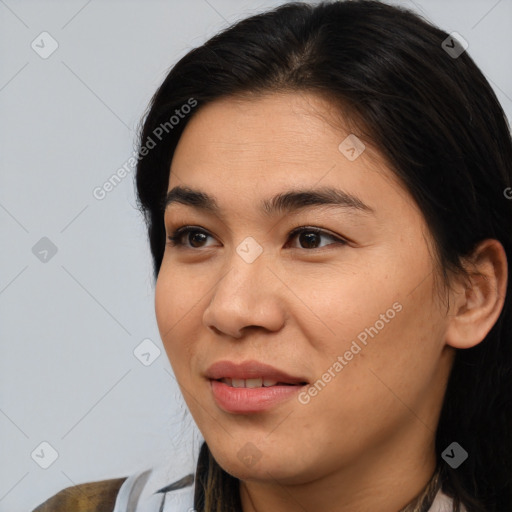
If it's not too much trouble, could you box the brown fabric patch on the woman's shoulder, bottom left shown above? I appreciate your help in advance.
[32,477,127,512]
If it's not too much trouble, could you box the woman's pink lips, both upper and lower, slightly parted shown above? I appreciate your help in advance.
[206,361,307,414]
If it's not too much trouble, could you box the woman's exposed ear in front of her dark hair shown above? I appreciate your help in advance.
[446,239,508,349]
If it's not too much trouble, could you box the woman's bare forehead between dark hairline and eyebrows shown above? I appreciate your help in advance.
[168,93,403,214]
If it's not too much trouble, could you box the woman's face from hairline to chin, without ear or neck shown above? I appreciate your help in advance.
[156,93,453,483]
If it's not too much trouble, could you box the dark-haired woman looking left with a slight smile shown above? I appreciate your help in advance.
[37,0,512,512]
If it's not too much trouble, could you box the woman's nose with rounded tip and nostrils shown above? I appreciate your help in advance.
[203,253,286,339]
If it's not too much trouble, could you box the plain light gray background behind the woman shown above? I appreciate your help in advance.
[0,0,512,512]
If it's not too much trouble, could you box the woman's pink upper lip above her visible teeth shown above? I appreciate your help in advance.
[205,361,307,384]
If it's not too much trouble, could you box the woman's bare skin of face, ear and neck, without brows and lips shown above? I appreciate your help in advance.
[155,93,507,512]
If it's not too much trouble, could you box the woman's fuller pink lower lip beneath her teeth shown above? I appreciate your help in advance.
[210,380,304,413]
